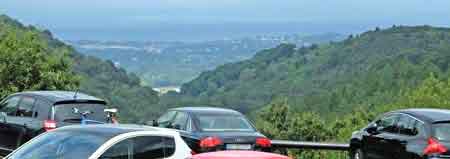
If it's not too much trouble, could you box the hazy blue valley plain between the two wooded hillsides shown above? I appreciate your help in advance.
[68,33,344,87]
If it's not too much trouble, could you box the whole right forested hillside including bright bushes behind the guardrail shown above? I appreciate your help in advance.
[167,26,450,159]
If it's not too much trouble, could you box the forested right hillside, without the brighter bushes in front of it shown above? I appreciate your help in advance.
[174,26,450,116]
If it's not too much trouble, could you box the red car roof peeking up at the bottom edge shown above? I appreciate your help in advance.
[190,151,291,159]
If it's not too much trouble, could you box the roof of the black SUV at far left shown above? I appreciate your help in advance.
[13,91,106,104]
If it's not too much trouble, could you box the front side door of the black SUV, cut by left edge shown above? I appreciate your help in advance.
[0,96,20,151]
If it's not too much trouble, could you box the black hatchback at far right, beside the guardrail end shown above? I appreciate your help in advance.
[350,109,450,159]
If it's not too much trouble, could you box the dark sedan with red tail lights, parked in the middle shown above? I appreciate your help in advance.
[152,107,271,153]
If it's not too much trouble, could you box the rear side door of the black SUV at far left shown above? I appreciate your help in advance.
[7,96,36,149]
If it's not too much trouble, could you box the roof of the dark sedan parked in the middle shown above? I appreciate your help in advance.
[169,106,242,115]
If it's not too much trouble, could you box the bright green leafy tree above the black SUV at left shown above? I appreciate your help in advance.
[0,28,79,98]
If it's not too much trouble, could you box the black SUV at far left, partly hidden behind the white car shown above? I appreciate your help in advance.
[0,91,107,154]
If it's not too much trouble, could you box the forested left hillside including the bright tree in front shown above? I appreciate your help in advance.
[0,15,160,122]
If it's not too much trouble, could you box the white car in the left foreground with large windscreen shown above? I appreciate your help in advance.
[4,124,192,159]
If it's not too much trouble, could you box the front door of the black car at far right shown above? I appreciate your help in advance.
[363,114,399,159]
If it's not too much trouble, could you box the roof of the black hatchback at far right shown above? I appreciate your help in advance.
[394,109,450,123]
